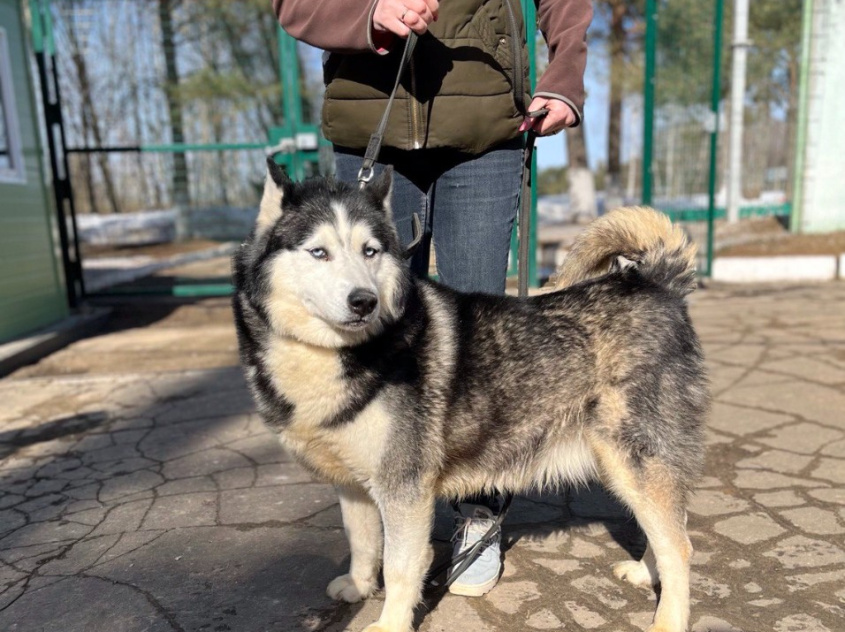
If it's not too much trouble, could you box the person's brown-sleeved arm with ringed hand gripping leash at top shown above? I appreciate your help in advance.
[273,0,437,54]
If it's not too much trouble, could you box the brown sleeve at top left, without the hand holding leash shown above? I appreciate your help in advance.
[273,0,385,53]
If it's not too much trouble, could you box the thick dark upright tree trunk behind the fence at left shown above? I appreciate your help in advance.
[158,0,191,209]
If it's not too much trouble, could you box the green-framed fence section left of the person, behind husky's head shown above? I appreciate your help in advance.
[29,0,330,298]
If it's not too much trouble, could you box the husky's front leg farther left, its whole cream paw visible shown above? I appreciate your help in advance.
[326,487,382,603]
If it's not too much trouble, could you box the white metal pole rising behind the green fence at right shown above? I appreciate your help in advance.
[727,0,750,223]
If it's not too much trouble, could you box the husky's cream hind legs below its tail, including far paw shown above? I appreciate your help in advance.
[593,443,692,632]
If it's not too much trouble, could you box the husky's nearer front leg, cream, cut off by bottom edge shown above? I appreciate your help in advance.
[364,495,434,632]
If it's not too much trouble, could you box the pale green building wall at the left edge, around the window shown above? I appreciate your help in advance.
[0,0,68,343]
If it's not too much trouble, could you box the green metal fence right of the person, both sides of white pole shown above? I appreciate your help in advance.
[641,0,800,275]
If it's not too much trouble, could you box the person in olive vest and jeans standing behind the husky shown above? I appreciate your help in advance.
[273,0,592,596]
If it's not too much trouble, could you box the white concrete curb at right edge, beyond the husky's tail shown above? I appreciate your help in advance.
[712,254,845,283]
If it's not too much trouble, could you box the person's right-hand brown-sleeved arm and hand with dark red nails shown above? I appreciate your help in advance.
[523,0,593,134]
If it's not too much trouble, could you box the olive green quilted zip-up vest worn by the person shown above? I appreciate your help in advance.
[323,0,531,154]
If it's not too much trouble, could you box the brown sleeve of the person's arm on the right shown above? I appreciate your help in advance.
[534,0,593,125]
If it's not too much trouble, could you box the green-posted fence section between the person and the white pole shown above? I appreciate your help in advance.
[642,0,724,276]
